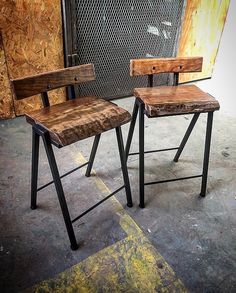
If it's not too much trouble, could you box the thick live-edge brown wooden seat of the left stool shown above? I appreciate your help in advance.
[26,97,131,146]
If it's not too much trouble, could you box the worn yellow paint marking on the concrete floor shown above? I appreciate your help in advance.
[27,154,187,293]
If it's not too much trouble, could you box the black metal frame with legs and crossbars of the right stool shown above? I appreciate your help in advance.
[125,73,214,208]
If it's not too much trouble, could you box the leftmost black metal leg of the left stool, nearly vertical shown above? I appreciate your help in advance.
[30,127,39,210]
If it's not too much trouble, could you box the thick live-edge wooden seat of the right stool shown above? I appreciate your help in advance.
[134,85,220,117]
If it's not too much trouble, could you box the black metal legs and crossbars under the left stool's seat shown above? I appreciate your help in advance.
[31,125,133,250]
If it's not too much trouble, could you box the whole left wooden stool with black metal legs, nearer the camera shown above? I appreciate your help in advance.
[12,64,132,250]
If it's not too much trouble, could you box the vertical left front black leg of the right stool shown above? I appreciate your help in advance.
[139,104,145,208]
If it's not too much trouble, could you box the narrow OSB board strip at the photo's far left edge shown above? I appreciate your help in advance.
[0,31,15,119]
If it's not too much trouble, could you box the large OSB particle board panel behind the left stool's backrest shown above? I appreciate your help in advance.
[0,0,65,115]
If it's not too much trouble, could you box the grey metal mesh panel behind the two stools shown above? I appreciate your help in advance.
[76,0,184,99]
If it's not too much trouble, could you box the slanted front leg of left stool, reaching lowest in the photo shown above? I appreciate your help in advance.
[42,133,78,250]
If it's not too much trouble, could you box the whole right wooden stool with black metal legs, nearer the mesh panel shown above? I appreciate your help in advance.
[125,57,219,208]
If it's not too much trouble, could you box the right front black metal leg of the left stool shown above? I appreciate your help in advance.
[116,126,133,208]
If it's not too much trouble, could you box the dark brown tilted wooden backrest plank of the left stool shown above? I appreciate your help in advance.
[11,64,95,100]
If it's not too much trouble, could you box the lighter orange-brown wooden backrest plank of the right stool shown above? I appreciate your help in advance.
[130,57,202,76]
